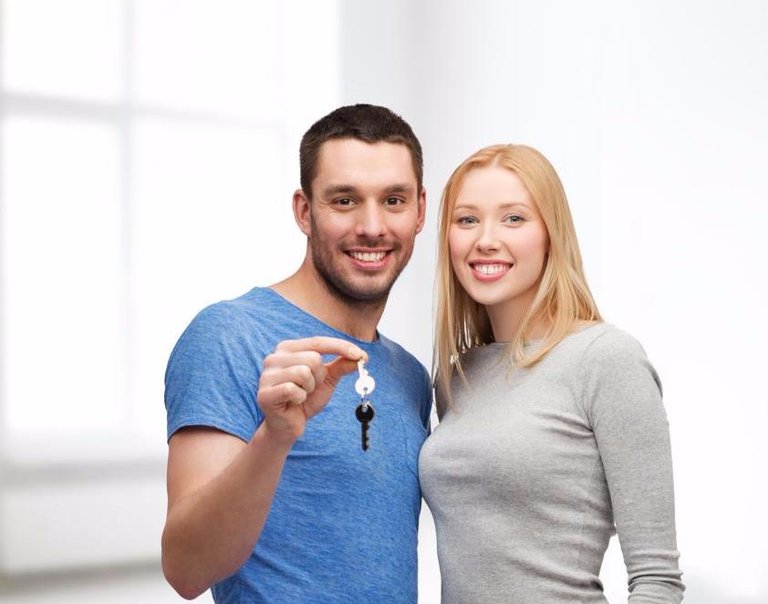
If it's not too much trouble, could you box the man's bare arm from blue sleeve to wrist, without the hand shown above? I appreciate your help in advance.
[162,424,290,599]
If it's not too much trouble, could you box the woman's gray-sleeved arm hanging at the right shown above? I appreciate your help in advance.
[582,329,685,604]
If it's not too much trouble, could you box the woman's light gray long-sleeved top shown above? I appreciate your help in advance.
[419,323,684,604]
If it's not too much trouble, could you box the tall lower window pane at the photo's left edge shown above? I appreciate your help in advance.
[0,119,123,435]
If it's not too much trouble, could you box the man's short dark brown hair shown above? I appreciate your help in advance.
[299,104,424,199]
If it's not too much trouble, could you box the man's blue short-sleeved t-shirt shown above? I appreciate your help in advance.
[165,288,432,604]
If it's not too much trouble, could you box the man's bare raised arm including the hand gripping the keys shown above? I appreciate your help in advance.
[162,337,365,599]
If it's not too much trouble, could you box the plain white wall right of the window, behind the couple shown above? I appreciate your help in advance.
[341,0,768,604]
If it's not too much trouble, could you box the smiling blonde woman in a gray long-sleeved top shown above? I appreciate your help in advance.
[420,145,684,604]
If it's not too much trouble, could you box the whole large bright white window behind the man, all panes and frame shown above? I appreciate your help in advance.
[0,0,339,570]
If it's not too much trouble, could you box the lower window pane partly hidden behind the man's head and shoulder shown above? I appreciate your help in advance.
[131,119,296,433]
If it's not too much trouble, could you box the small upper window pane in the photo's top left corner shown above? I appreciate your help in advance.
[2,0,123,100]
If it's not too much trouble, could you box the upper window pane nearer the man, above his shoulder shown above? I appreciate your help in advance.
[133,0,280,119]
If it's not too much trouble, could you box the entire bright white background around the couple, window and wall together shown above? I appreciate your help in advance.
[0,0,768,604]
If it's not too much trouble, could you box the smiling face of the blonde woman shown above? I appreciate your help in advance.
[448,166,549,332]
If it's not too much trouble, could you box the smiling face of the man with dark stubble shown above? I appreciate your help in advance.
[305,139,425,303]
